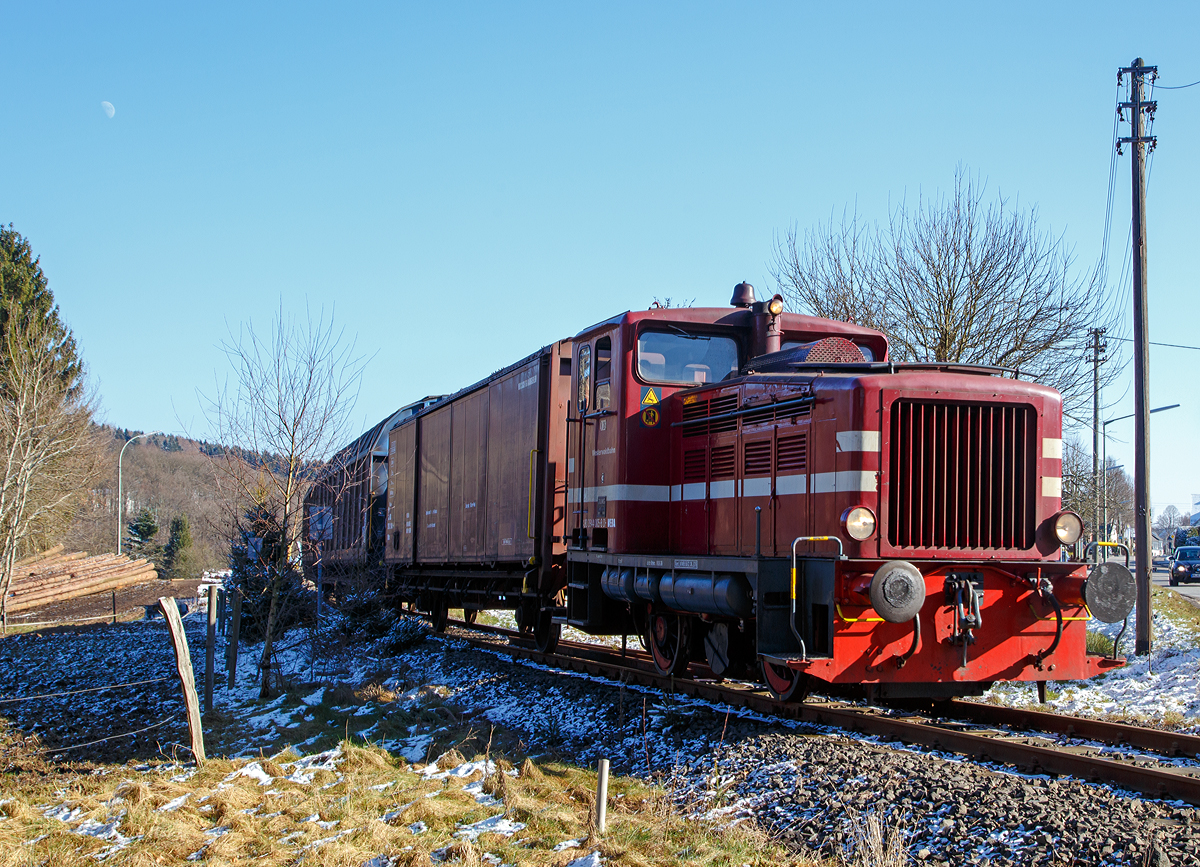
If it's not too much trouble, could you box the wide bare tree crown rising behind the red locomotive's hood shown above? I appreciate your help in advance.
[772,169,1121,409]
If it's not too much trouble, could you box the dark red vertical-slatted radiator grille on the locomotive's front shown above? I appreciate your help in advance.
[887,400,1037,550]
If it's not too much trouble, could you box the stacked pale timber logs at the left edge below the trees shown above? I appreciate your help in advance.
[7,545,158,614]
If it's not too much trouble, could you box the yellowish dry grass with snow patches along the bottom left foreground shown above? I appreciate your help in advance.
[0,743,830,867]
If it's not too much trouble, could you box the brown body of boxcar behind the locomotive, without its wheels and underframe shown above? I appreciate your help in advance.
[385,342,570,575]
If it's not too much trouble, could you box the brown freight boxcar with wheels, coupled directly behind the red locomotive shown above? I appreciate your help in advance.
[384,341,572,641]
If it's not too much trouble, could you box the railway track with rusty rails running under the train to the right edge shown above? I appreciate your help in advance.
[439,621,1200,806]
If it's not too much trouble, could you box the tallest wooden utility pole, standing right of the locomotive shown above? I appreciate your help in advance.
[1117,58,1158,656]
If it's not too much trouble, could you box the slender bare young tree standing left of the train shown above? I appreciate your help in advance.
[202,303,366,698]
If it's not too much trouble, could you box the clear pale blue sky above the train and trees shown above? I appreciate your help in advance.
[0,2,1200,508]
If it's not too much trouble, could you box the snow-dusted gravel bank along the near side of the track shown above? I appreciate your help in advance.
[427,629,1200,867]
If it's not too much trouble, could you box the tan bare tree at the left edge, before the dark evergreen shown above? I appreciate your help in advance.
[0,305,102,616]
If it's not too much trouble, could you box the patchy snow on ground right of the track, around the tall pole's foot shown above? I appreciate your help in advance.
[984,595,1200,731]
